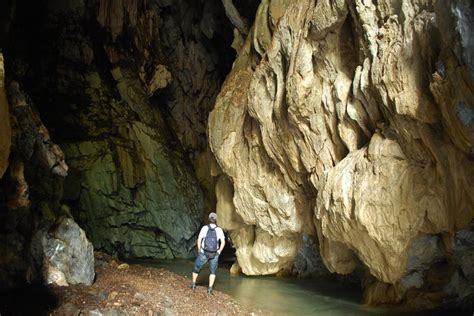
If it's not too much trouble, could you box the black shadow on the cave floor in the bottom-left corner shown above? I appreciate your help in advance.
[0,285,58,316]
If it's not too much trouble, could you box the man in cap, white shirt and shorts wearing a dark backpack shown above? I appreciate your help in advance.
[191,212,225,294]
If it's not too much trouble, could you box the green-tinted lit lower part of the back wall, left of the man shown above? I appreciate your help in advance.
[63,126,202,259]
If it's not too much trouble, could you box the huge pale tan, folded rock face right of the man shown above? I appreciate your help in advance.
[209,0,474,306]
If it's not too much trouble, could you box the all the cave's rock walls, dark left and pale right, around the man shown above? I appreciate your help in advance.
[0,0,474,314]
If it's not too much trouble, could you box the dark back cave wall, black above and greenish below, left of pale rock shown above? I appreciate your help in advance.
[2,0,232,258]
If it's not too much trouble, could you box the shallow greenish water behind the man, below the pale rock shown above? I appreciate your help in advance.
[135,260,448,316]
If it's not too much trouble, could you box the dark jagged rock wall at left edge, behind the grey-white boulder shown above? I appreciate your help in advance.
[0,81,68,287]
